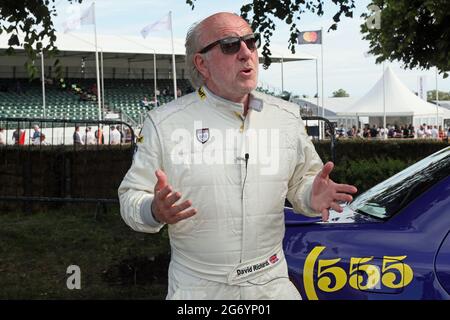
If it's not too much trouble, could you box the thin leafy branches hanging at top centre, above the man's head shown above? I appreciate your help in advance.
[186,0,355,69]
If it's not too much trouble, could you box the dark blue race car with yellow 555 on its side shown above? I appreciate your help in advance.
[283,147,450,300]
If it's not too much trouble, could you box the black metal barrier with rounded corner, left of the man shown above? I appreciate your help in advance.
[0,118,136,210]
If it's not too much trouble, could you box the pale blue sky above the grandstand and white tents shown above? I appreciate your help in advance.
[54,0,450,98]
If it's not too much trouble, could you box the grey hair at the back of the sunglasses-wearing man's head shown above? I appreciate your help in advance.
[185,22,205,89]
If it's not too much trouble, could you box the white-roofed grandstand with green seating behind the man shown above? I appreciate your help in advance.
[0,33,315,126]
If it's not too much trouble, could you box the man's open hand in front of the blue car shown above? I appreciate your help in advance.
[311,162,358,221]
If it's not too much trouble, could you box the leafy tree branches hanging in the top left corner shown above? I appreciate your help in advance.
[0,0,82,78]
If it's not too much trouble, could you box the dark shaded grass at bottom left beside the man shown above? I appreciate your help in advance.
[0,207,169,299]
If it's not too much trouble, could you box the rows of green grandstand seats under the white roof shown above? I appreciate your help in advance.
[0,79,190,122]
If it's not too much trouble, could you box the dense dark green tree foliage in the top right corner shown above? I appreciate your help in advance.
[361,0,450,78]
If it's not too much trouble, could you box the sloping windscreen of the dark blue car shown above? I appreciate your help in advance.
[350,147,450,220]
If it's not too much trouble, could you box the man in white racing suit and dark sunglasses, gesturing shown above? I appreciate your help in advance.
[119,13,356,300]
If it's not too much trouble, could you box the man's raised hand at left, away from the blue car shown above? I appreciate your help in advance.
[152,170,197,224]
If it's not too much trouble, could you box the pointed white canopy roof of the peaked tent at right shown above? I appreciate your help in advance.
[337,66,447,118]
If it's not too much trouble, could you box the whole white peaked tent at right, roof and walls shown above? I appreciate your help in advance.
[337,67,450,126]
